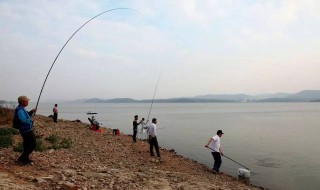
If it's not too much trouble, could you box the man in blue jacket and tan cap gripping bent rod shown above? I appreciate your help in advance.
[13,96,36,164]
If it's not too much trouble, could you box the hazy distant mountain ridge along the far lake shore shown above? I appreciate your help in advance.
[83,90,320,103]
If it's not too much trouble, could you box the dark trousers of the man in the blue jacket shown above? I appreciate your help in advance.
[19,131,36,161]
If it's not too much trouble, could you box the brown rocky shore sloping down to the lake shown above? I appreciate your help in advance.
[0,116,262,190]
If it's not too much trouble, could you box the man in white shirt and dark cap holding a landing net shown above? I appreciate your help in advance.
[205,130,224,174]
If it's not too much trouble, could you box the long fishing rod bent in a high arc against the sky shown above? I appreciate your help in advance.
[34,8,136,115]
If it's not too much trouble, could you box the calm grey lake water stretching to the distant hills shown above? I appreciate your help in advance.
[28,102,320,190]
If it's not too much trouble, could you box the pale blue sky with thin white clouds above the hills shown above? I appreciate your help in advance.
[0,0,320,101]
